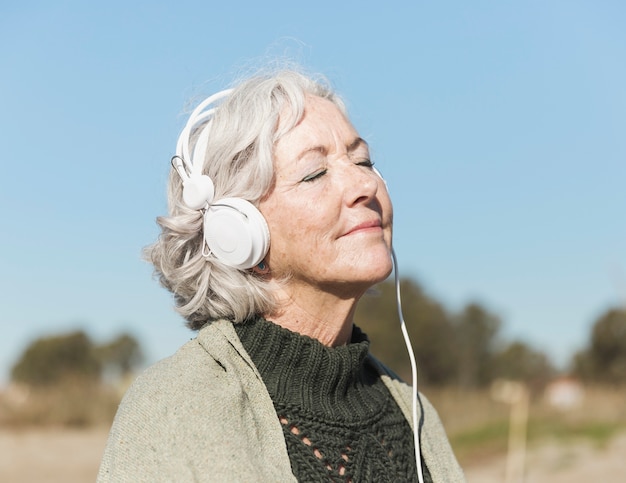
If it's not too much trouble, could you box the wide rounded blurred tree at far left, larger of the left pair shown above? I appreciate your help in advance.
[11,331,100,386]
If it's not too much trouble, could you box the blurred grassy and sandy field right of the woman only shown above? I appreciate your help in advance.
[426,387,626,483]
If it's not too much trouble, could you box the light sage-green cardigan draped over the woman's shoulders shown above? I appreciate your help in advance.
[98,320,465,483]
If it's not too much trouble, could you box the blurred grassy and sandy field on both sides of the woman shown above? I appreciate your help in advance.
[0,388,626,483]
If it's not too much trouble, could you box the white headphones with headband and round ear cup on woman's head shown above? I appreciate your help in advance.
[172,90,270,270]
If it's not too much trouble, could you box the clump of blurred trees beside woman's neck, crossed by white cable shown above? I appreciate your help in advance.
[355,279,553,388]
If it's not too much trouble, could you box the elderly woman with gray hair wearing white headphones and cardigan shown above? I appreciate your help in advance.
[99,71,463,482]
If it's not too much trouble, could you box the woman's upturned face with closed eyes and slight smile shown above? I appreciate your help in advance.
[259,96,392,296]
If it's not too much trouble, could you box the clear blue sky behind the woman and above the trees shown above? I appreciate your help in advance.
[0,0,626,382]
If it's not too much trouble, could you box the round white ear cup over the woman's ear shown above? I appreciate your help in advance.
[203,198,270,270]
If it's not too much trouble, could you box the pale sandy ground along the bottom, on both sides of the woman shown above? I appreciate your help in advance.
[0,428,626,483]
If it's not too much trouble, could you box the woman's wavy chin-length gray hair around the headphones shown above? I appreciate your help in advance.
[144,70,345,330]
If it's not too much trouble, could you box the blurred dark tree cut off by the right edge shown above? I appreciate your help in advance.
[573,309,626,384]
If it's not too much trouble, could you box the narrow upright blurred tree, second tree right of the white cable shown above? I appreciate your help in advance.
[455,303,501,388]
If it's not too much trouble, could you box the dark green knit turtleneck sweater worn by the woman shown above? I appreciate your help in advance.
[235,319,431,482]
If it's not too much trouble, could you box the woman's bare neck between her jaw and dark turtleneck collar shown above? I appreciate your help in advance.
[266,284,361,347]
